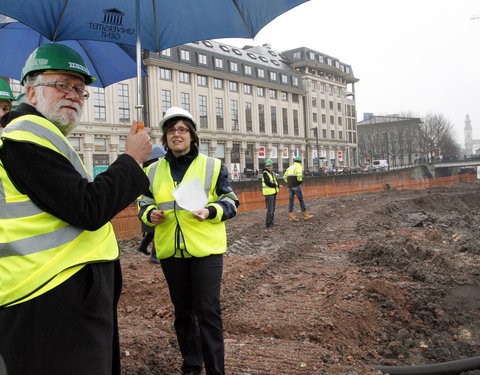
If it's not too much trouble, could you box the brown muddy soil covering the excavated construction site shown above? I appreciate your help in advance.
[119,182,480,375]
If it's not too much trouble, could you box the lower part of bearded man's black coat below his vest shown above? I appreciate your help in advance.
[0,261,121,375]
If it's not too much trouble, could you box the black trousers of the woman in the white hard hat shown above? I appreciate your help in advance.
[161,255,225,375]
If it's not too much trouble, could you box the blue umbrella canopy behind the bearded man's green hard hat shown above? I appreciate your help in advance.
[0,22,144,87]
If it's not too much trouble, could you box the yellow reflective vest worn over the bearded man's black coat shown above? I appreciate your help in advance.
[0,115,119,308]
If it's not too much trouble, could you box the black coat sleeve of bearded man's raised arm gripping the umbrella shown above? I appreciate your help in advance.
[0,140,149,230]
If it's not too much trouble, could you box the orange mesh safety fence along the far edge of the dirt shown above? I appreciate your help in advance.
[112,174,477,239]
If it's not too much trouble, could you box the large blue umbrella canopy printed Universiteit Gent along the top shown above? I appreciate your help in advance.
[0,0,308,51]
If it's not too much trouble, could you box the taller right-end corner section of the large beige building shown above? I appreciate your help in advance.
[282,47,358,170]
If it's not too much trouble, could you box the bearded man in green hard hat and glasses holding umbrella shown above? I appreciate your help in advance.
[0,43,152,375]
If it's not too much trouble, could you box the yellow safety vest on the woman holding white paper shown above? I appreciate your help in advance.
[139,154,236,259]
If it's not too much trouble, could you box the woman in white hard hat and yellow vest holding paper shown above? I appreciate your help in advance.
[138,107,240,375]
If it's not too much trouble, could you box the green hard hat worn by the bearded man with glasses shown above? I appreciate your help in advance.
[21,43,97,85]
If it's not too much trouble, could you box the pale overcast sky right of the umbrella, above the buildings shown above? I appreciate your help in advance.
[218,0,480,147]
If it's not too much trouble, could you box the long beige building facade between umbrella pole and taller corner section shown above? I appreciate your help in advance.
[144,41,306,175]
